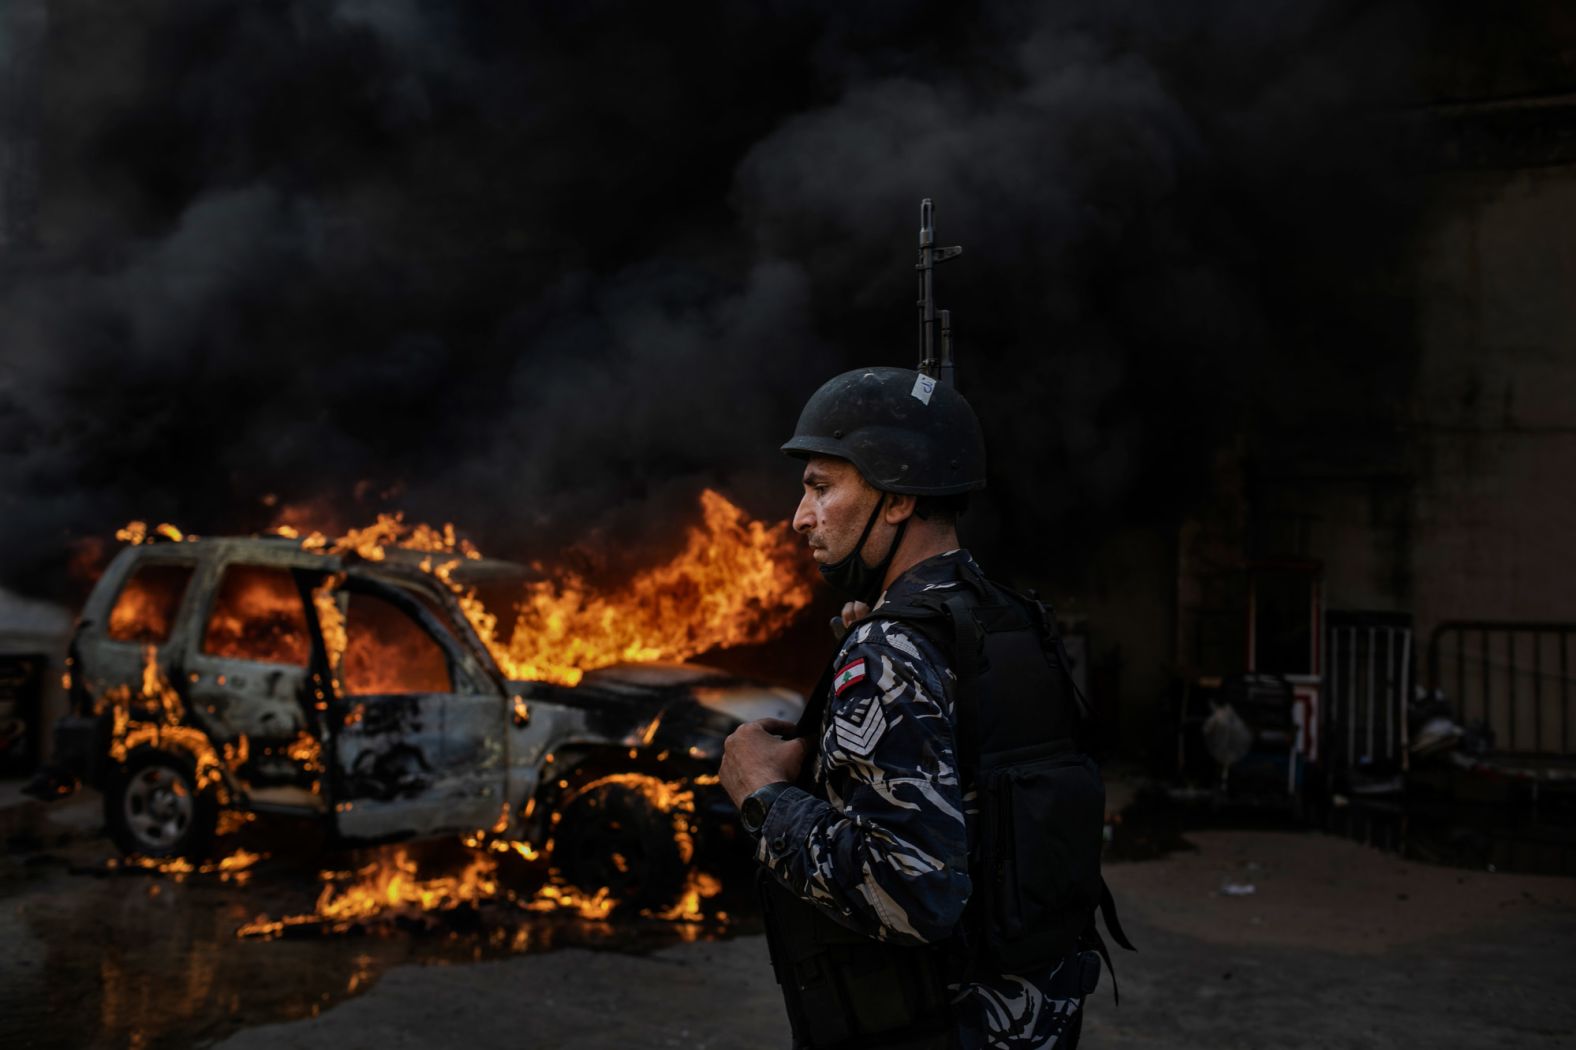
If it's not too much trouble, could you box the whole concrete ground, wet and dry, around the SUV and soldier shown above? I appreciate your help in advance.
[0,772,1576,1050]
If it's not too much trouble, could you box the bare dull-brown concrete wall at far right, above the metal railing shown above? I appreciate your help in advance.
[1411,167,1576,632]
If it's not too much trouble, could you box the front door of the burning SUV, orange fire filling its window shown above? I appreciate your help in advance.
[320,572,506,839]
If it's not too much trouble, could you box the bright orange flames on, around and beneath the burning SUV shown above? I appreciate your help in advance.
[101,490,788,938]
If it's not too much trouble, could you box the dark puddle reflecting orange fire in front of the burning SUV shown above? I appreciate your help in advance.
[0,800,758,1050]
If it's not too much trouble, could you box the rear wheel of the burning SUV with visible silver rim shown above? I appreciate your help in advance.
[104,749,219,861]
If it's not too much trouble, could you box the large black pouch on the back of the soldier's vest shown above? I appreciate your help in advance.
[979,749,1105,973]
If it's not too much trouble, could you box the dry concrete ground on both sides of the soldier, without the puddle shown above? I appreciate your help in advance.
[206,831,1576,1050]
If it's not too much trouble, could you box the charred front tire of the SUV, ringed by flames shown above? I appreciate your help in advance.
[552,774,689,910]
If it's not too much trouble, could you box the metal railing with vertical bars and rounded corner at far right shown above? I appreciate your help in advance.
[1428,620,1576,755]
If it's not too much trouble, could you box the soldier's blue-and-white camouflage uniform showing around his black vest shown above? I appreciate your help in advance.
[756,550,1083,1050]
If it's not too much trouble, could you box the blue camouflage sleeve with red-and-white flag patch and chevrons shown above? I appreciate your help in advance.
[756,620,971,944]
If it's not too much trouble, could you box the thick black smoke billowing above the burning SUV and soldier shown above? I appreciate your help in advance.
[0,0,1422,593]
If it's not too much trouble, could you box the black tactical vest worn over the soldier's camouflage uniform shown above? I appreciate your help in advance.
[758,566,1133,1050]
